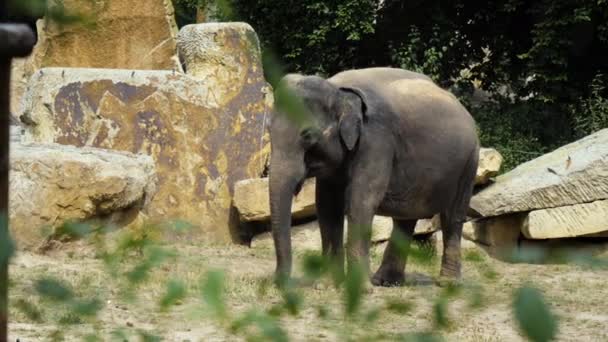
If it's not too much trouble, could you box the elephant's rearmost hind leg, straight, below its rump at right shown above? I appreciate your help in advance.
[439,149,478,280]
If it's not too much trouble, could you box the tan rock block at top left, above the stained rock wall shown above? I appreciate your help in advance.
[31,0,179,71]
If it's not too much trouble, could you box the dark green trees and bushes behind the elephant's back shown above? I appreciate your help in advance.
[217,0,608,171]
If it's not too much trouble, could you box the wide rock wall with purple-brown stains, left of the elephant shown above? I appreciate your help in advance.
[22,67,269,240]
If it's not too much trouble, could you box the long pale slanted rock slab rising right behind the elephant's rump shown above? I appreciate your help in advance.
[471,129,608,217]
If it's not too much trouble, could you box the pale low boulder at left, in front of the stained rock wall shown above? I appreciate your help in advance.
[9,144,157,248]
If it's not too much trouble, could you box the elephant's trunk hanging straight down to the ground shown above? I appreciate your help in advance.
[270,153,305,283]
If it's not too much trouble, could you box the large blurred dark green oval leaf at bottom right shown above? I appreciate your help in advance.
[513,286,557,342]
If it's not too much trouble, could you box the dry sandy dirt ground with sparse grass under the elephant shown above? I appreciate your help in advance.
[9,231,608,342]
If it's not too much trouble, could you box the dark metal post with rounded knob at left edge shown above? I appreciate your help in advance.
[0,0,35,342]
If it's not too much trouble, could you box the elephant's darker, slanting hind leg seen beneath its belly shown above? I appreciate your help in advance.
[372,219,417,286]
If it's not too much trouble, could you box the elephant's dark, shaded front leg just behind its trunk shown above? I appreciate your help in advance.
[316,179,344,282]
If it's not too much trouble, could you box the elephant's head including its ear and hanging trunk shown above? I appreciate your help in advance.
[270,74,366,281]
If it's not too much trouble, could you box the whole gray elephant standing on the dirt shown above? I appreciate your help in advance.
[270,68,479,286]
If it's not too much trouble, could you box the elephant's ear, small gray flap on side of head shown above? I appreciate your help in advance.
[338,88,367,151]
